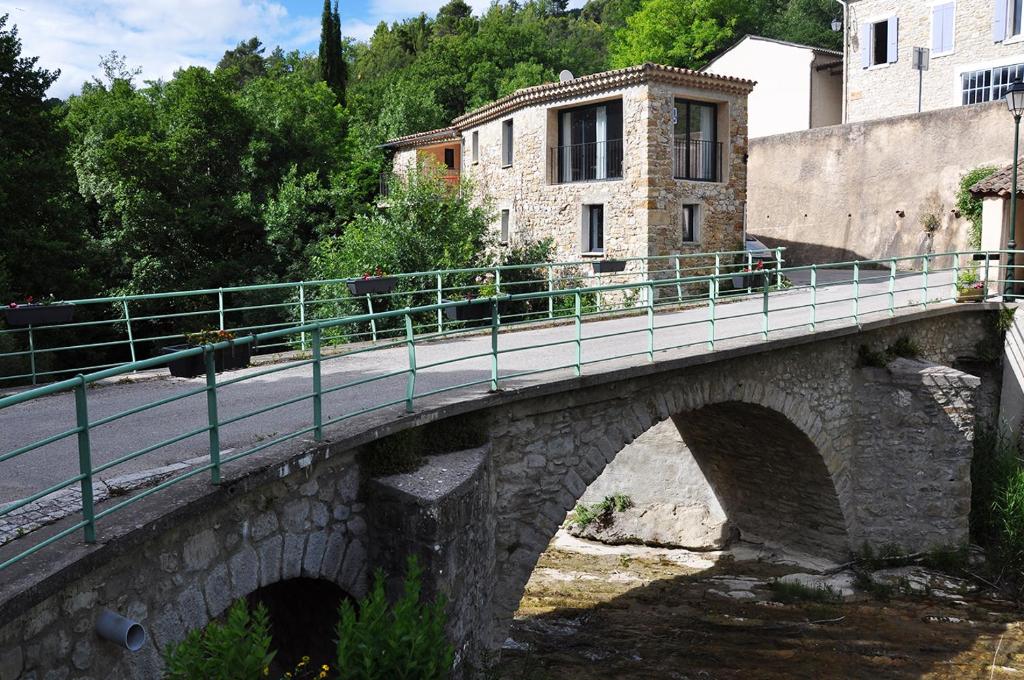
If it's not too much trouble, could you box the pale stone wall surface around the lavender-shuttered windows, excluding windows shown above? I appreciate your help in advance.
[846,0,1024,122]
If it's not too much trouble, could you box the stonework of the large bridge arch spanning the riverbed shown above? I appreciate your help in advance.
[484,363,853,647]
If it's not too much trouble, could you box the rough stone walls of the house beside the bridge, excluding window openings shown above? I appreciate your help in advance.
[393,65,753,268]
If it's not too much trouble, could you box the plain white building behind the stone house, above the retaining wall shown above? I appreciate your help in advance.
[701,36,843,139]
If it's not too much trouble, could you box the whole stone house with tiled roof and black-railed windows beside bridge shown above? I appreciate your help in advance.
[385,63,754,259]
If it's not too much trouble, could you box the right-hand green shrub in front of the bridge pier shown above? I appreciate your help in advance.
[336,557,455,680]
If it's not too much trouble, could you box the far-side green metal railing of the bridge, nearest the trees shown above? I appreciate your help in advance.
[0,248,783,385]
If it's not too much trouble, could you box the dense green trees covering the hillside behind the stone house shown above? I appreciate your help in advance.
[0,0,839,299]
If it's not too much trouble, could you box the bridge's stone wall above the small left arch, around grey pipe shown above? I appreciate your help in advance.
[0,456,367,680]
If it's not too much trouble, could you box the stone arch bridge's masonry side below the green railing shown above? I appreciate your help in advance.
[0,305,998,680]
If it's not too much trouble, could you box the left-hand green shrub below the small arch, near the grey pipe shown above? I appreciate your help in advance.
[164,600,275,680]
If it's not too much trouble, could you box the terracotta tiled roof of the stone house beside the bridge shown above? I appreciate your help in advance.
[384,63,755,147]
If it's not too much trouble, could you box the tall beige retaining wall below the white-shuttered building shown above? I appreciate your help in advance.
[746,102,1013,264]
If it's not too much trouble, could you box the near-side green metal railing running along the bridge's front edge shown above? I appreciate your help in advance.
[0,246,1024,570]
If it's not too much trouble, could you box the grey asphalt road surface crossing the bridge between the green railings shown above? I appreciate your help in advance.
[0,271,952,504]
